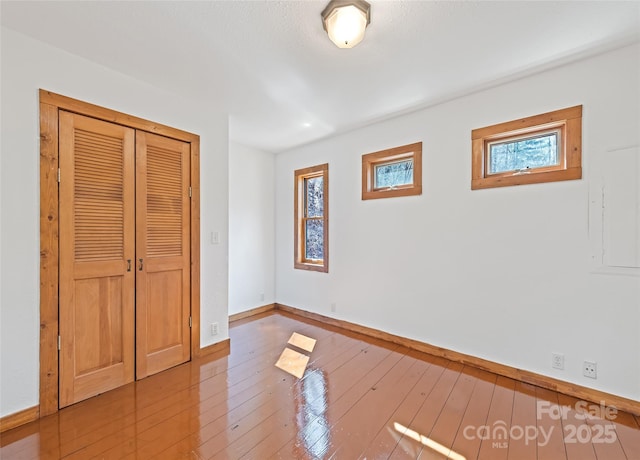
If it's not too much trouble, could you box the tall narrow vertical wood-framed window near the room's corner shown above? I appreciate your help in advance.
[294,164,329,272]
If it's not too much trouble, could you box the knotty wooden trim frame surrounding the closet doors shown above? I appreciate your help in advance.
[39,89,201,417]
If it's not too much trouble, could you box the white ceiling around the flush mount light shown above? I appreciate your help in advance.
[0,0,640,152]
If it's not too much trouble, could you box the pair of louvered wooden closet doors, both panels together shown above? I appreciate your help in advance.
[59,111,191,407]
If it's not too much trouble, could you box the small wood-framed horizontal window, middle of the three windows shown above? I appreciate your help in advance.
[362,142,422,200]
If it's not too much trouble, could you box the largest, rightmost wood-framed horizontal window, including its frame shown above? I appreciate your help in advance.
[471,106,582,189]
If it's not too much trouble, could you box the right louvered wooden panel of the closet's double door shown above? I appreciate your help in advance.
[136,131,191,378]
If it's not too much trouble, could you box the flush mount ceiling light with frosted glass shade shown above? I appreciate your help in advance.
[322,0,371,48]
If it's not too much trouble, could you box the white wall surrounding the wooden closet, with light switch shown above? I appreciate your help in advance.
[0,28,228,416]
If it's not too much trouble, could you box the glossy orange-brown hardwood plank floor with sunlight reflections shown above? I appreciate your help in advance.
[0,312,640,460]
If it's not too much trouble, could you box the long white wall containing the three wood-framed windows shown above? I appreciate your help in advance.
[276,45,640,400]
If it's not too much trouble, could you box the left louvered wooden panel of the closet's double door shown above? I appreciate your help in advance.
[59,111,135,407]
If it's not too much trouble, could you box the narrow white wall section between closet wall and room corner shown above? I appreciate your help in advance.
[229,142,275,314]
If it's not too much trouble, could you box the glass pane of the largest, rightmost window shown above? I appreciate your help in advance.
[488,132,559,174]
